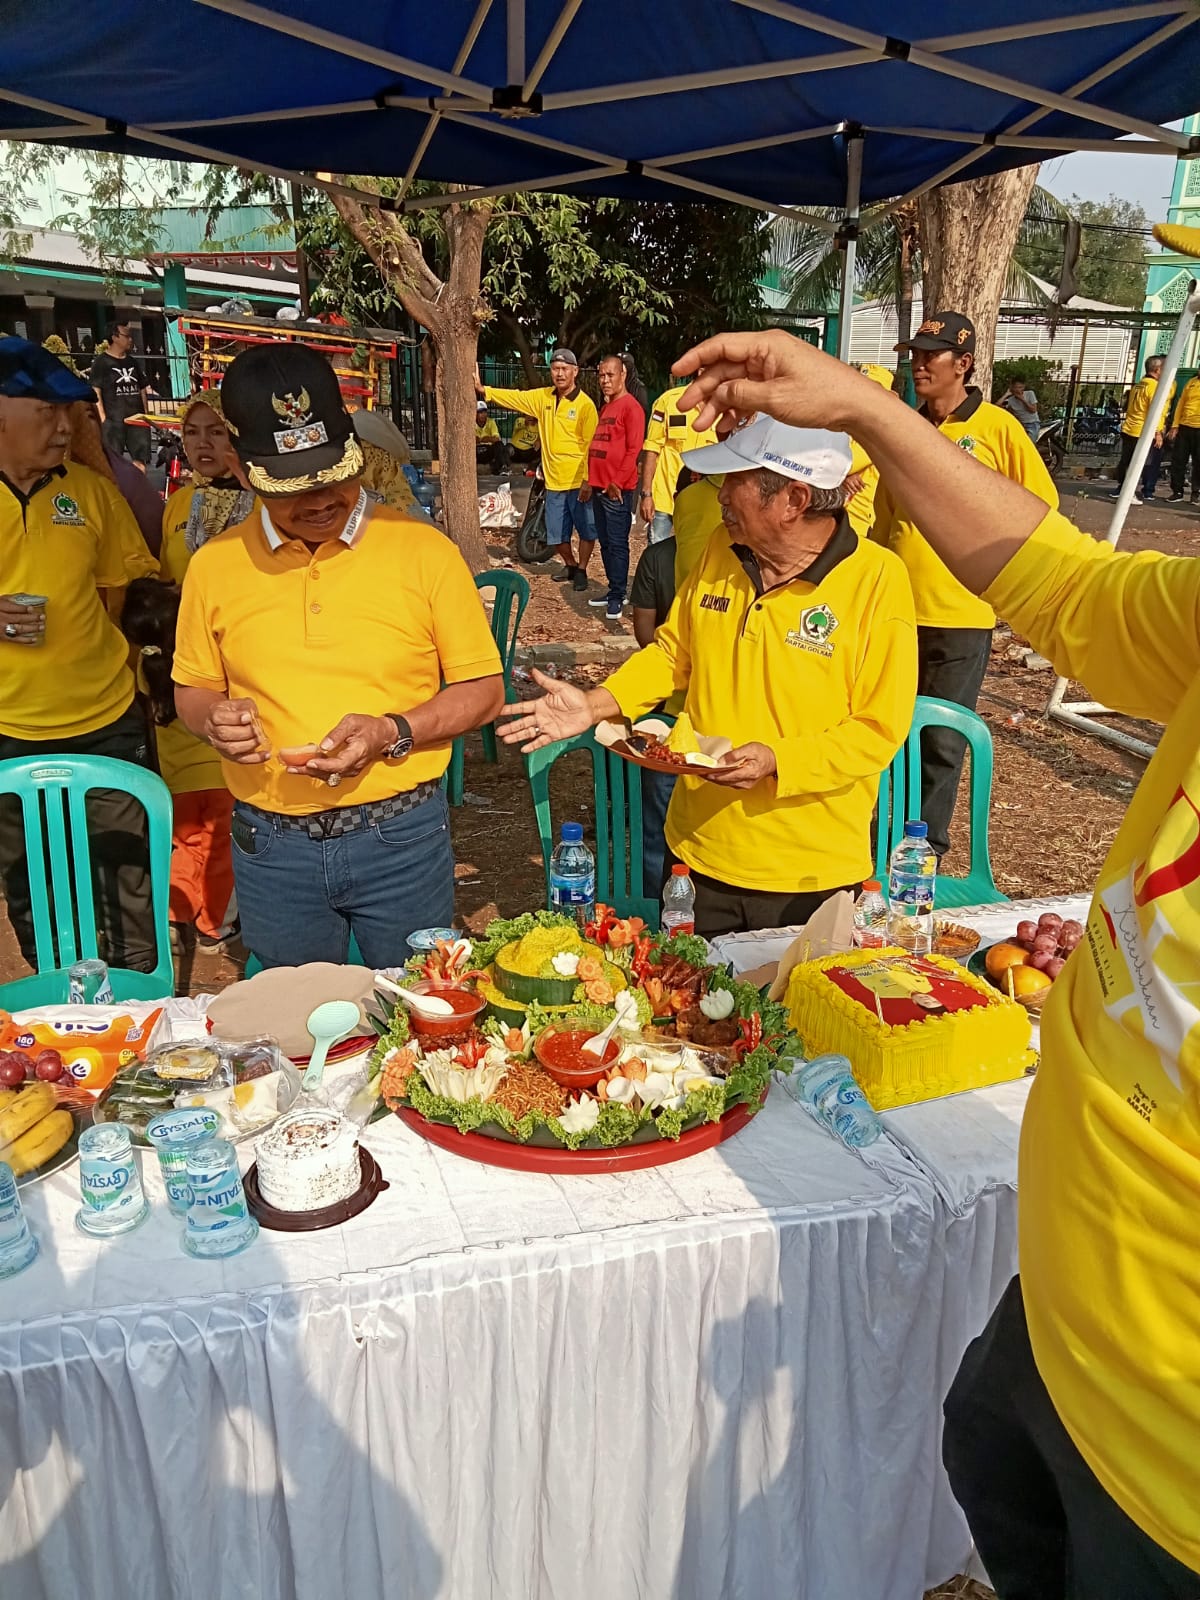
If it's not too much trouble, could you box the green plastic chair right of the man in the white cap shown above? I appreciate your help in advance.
[875,694,1008,910]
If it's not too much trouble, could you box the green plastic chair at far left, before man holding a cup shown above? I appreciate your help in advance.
[0,755,174,1011]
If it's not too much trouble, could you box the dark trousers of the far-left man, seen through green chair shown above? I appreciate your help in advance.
[0,701,157,973]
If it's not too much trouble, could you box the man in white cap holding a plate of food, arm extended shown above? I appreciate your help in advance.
[504,416,917,938]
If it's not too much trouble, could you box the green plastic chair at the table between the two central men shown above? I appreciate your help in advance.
[525,730,659,930]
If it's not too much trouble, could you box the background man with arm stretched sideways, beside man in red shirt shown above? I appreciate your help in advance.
[475,350,597,594]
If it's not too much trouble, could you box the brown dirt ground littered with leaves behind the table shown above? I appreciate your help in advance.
[0,482,1200,992]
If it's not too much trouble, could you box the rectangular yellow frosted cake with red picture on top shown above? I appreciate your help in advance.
[787,949,1035,1110]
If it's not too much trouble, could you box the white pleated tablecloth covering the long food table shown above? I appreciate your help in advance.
[0,907,1088,1600]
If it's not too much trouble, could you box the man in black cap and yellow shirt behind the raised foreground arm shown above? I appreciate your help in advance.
[872,310,1058,856]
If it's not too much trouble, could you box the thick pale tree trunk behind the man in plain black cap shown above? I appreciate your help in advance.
[917,166,1037,400]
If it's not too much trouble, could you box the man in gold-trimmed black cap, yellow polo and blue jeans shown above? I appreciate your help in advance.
[174,346,504,966]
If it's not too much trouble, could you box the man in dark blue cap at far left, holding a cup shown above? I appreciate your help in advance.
[0,339,158,971]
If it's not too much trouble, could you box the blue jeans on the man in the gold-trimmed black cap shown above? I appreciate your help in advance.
[234,789,454,966]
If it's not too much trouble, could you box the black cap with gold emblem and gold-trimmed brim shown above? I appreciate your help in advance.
[221,344,363,494]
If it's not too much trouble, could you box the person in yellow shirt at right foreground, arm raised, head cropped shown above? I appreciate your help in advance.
[675,331,1200,1600]
